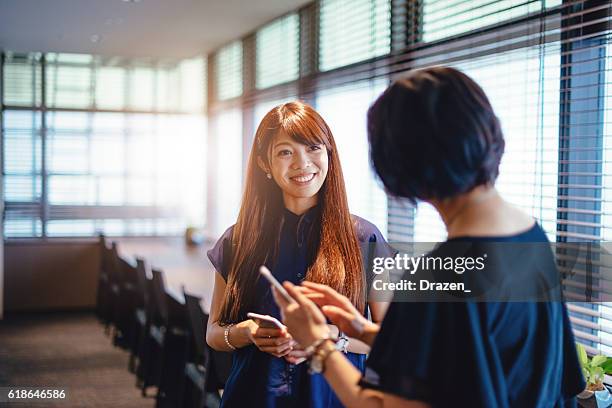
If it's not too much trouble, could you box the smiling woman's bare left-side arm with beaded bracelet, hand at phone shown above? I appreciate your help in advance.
[206,272,291,357]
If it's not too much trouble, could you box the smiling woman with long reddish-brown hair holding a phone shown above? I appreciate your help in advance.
[206,102,392,407]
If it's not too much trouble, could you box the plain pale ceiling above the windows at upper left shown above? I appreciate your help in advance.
[0,0,311,58]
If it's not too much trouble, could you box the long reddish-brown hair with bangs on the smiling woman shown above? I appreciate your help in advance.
[219,102,365,324]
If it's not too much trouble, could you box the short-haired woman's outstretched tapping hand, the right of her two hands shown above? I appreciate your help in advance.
[298,281,378,343]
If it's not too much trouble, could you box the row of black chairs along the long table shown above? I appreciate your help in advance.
[96,235,231,408]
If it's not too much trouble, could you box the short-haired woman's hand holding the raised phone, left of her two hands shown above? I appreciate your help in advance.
[272,282,330,348]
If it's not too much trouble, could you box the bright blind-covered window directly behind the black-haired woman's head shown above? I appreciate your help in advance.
[415,45,560,242]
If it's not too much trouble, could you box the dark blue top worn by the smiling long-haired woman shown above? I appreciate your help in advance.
[208,207,395,408]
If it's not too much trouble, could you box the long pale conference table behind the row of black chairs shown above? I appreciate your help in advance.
[117,237,215,313]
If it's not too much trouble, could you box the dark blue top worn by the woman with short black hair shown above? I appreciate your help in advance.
[361,224,585,407]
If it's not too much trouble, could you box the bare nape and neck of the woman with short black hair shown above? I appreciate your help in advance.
[431,186,533,238]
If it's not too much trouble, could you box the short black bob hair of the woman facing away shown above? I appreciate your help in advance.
[368,67,504,203]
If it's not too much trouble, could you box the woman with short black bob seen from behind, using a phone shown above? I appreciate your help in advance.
[275,67,584,408]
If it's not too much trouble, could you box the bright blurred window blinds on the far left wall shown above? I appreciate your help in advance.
[2,53,206,238]
